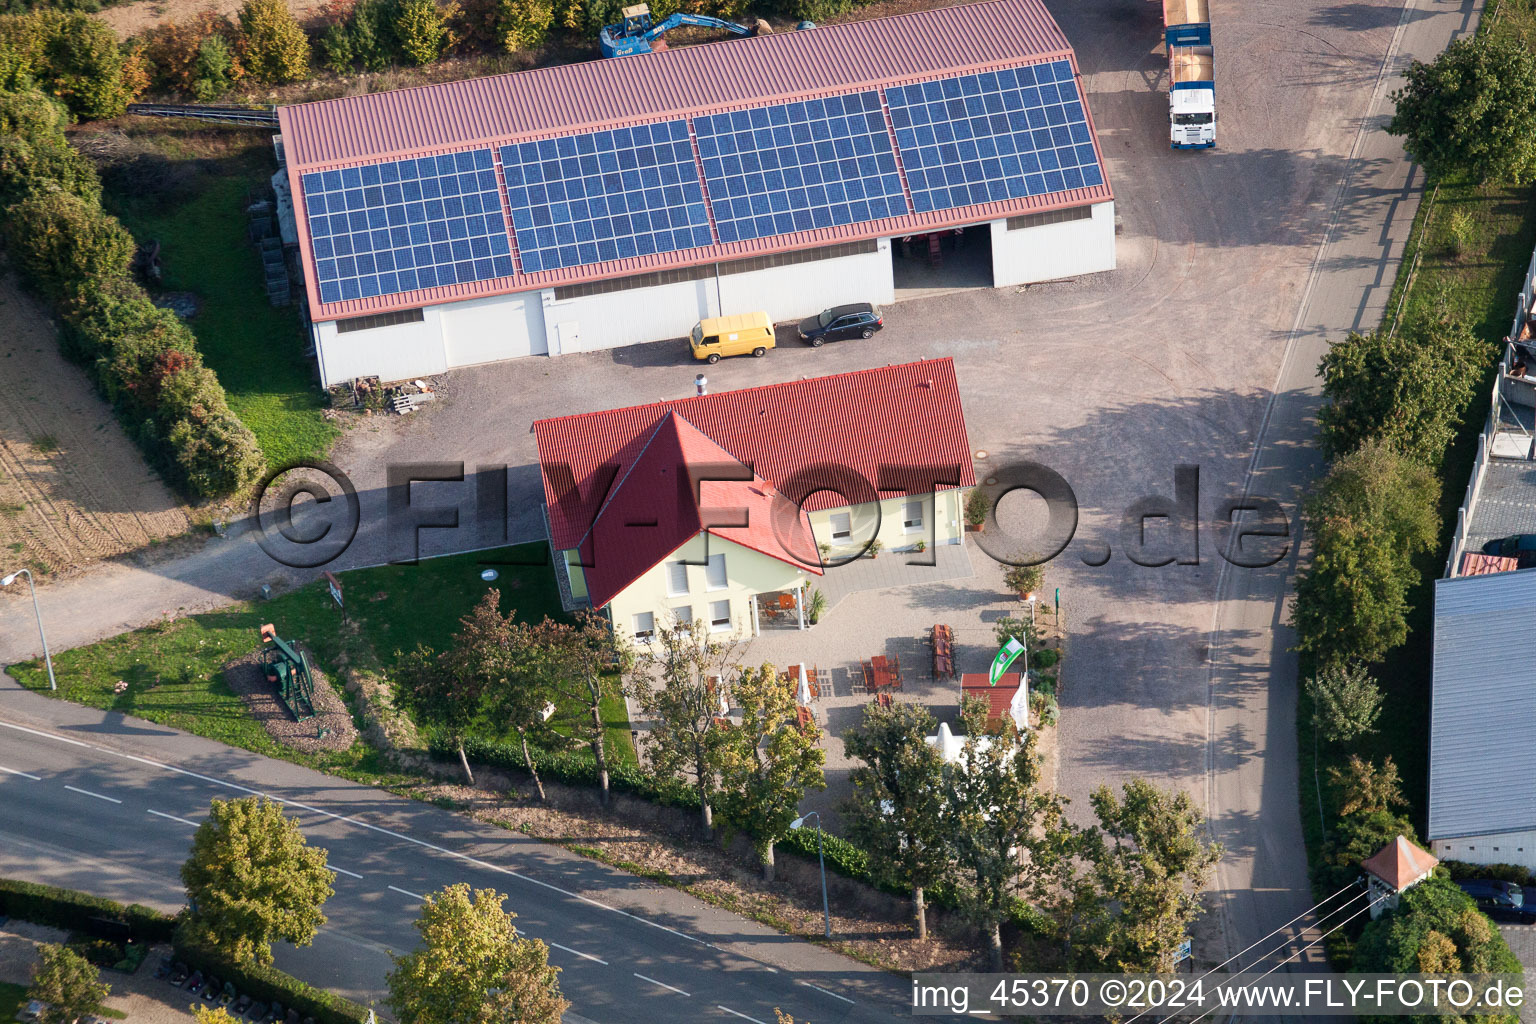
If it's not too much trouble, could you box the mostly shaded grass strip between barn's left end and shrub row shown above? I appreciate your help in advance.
[104,123,339,465]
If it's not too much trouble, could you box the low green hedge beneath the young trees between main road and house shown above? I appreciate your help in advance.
[427,735,1037,929]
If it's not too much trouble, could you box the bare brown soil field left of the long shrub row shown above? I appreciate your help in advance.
[0,278,192,574]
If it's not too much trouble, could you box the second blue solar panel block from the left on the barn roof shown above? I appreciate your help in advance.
[501,121,714,273]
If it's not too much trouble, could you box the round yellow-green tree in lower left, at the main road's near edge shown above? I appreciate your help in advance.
[181,797,333,964]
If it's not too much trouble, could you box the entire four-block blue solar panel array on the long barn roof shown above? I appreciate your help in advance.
[293,60,1104,302]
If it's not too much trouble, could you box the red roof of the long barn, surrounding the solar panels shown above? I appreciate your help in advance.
[278,0,1114,321]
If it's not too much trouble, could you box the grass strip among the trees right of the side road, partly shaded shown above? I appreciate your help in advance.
[1296,0,1536,895]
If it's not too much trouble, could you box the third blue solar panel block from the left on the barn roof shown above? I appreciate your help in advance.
[693,92,908,243]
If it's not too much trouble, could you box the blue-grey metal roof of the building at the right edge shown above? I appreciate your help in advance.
[1428,570,1536,867]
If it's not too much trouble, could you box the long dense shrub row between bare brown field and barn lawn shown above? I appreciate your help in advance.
[0,92,263,497]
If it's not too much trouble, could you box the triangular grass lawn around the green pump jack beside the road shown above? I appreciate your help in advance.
[11,543,634,781]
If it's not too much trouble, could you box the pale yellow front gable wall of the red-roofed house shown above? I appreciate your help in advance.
[608,533,814,639]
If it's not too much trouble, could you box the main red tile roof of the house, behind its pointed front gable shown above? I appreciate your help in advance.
[533,359,975,555]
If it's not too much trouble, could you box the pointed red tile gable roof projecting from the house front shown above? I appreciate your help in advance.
[581,413,822,608]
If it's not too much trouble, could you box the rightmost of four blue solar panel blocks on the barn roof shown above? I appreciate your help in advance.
[885,60,1104,213]
